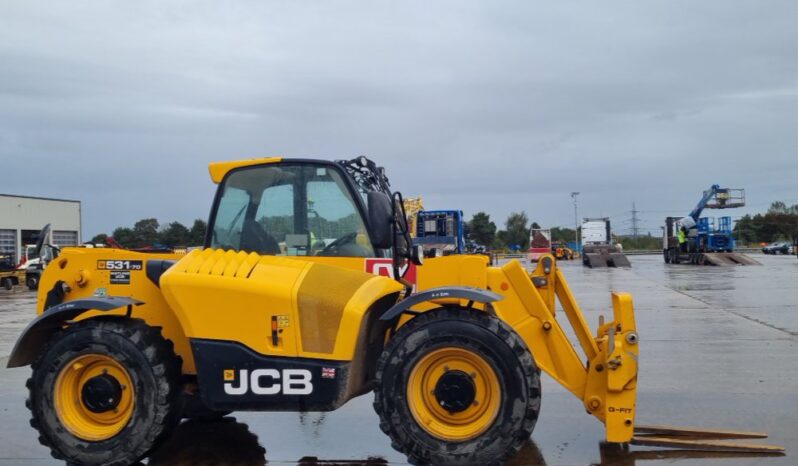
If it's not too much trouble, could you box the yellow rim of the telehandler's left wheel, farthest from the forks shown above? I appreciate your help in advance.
[53,354,134,442]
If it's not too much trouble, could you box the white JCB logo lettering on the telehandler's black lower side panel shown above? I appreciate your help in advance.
[224,369,313,395]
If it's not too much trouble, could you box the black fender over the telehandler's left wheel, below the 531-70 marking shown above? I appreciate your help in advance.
[7,296,144,367]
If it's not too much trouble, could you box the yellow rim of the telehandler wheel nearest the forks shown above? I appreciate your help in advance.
[407,347,501,442]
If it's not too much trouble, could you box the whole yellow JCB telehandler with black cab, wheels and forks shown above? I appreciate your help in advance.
[8,157,780,465]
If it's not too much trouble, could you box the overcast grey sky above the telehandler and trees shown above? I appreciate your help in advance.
[0,0,798,239]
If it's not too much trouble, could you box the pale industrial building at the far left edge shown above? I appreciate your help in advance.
[0,194,81,261]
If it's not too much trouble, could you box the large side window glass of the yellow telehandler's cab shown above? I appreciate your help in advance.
[211,163,374,257]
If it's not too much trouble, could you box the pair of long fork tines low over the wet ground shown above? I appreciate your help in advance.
[630,426,785,455]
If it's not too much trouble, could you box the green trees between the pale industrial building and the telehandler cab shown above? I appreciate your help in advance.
[91,218,208,249]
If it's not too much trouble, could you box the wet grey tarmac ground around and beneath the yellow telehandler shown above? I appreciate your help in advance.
[0,255,798,466]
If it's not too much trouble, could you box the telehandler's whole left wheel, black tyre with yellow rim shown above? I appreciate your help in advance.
[27,318,182,466]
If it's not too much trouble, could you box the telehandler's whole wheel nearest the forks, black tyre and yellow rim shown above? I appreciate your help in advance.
[374,309,541,465]
